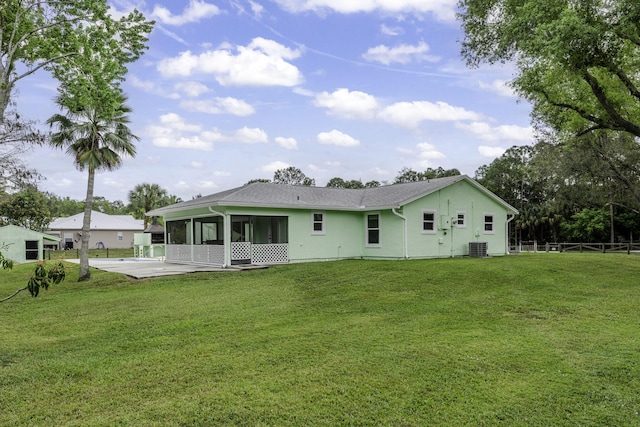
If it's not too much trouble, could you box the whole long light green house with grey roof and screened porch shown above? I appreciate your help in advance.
[147,175,518,266]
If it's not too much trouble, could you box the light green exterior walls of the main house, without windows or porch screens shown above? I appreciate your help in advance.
[154,180,507,262]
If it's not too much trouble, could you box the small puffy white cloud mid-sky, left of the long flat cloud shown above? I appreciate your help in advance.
[313,88,378,119]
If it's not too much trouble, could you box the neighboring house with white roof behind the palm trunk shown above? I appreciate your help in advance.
[48,211,144,249]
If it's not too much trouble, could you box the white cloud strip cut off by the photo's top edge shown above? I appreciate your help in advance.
[275,0,458,21]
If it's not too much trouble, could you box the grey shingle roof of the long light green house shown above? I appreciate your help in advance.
[147,175,517,216]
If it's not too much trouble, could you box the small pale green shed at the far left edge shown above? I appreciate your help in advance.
[0,225,60,263]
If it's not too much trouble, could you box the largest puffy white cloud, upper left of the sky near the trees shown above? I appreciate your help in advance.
[157,37,303,87]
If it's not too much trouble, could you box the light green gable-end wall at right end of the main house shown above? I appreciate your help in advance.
[403,181,507,258]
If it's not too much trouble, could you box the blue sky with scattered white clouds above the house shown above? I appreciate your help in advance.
[17,0,533,203]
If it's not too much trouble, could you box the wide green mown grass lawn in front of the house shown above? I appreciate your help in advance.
[0,254,640,426]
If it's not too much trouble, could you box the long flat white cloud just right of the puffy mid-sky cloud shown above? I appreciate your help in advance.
[378,101,480,128]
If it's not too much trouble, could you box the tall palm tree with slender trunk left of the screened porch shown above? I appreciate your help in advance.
[47,93,139,281]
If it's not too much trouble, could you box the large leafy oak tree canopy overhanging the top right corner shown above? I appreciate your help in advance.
[459,0,640,137]
